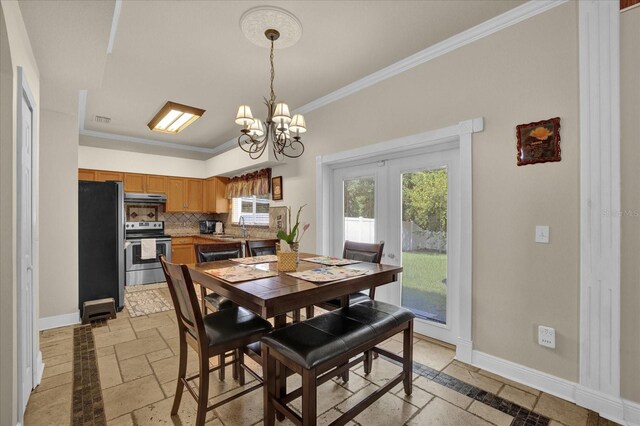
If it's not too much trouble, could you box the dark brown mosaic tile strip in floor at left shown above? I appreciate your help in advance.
[71,325,107,426]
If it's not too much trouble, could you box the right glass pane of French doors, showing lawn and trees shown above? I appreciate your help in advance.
[402,167,447,324]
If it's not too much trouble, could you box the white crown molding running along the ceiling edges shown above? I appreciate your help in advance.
[78,0,568,156]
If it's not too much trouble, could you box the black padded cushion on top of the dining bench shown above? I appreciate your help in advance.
[262,300,414,369]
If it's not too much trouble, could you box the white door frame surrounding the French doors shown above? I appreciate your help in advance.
[316,117,484,364]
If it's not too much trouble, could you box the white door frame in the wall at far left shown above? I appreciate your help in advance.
[16,67,44,422]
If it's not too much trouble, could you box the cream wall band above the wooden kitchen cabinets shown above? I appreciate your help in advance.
[76,145,206,179]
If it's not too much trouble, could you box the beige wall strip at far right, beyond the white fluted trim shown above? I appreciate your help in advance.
[620,7,640,403]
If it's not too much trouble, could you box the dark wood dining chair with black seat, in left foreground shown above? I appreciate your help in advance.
[160,256,272,426]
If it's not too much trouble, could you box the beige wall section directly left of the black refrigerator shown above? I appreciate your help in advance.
[40,109,78,318]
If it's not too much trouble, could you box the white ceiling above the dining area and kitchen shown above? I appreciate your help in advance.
[20,0,523,158]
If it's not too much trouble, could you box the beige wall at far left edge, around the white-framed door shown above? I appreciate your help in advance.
[0,0,40,425]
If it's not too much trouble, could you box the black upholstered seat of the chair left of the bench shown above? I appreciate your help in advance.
[203,306,273,346]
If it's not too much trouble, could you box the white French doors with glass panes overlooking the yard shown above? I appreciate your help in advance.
[332,148,460,344]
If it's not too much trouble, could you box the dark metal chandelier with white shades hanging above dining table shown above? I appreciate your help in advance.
[236,29,307,161]
